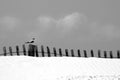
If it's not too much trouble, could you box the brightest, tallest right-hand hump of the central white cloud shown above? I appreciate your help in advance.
[57,12,87,32]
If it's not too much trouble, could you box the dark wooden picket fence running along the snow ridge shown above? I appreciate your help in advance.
[0,44,120,58]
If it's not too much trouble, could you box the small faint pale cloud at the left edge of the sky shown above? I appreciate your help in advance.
[0,16,19,31]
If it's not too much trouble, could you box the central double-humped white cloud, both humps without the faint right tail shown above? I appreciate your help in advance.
[34,12,87,37]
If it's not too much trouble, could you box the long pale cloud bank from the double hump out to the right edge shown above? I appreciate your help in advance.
[34,12,120,40]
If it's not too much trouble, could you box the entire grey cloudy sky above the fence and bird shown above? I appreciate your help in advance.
[0,0,120,53]
